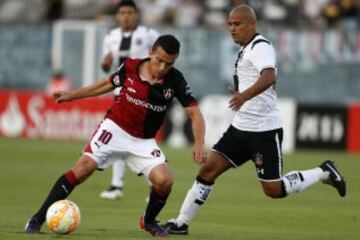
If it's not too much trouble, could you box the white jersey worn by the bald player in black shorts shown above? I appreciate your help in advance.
[232,34,282,132]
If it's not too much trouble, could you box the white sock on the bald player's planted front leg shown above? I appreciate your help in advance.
[176,181,213,226]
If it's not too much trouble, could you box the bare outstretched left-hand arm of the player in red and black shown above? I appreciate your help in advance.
[53,79,114,103]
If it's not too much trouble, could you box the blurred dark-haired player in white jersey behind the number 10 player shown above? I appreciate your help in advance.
[100,0,159,200]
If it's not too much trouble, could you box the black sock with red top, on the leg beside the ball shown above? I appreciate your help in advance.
[34,170,79,223]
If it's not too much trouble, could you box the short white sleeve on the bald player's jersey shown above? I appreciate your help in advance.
[250,42,276,73]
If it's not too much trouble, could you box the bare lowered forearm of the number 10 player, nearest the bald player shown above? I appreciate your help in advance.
[185,106,206,163]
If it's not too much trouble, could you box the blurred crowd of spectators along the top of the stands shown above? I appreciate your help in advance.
[0,0,360,29]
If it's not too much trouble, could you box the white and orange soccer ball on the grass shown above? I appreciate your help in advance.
[46,200,80,234]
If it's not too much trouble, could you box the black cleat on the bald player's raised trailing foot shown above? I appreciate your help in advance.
[320,160,346,197]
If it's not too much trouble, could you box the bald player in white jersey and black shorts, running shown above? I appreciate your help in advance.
[162,5,346,234]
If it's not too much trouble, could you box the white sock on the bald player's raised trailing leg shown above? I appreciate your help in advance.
[282,167,329,195]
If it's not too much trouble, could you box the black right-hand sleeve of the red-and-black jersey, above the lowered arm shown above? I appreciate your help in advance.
[174,75,198,107]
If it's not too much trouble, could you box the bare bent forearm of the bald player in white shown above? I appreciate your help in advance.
[229,68,276,111]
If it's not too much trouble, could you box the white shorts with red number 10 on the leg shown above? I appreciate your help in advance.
[83,119,166,177]
